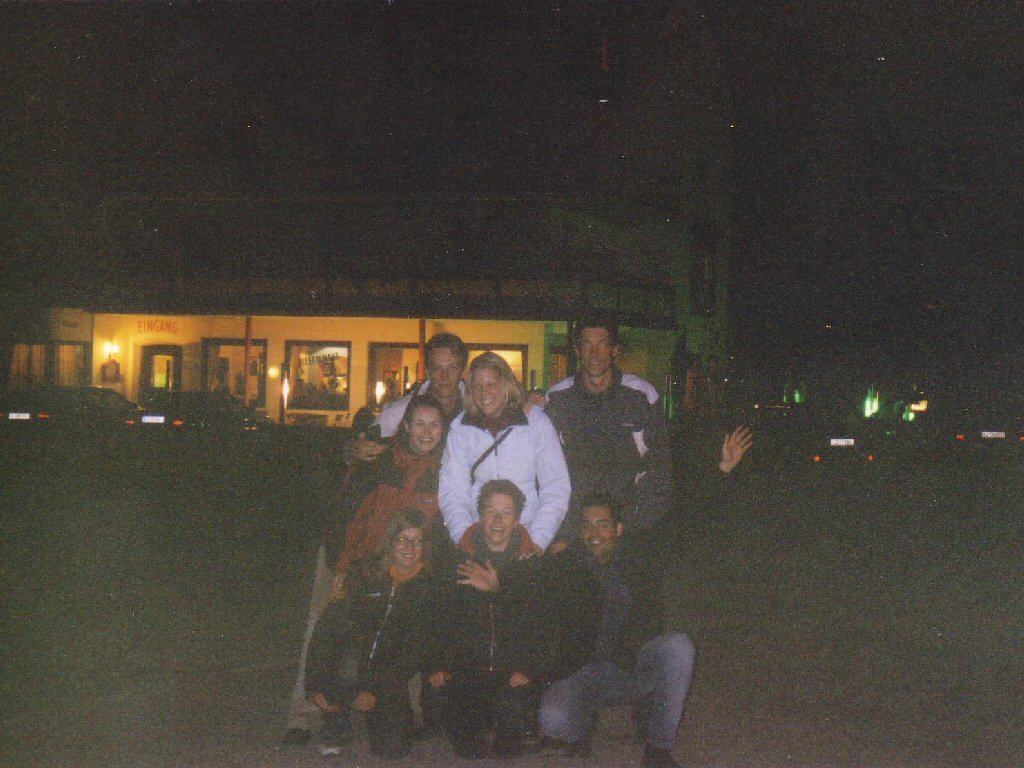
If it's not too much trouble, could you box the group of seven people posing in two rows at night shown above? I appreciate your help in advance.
[286,316,751,768]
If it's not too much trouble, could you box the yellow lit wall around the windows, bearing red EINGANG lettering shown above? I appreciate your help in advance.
[44,309,675,426]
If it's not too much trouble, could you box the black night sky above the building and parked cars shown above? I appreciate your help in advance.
[0,0,1024,370]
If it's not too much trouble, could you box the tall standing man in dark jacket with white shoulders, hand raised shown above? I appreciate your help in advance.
[545,314,751,545]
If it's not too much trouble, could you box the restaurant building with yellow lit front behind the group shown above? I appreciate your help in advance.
[3,201,728,426]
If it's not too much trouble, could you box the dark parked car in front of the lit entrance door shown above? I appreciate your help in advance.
[140,390,273,432]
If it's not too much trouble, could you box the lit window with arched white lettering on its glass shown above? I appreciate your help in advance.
[285,341,352,411]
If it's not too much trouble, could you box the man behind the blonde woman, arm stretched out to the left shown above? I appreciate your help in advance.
[352,333,469,461]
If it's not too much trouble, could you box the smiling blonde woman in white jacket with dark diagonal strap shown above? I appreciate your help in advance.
[438,352,569,551]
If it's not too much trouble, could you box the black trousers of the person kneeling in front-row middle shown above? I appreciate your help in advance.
[424,672,540,758]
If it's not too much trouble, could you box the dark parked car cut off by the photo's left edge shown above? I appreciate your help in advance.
[0,386,142,431]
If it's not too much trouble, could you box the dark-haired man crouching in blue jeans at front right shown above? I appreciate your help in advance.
[540,496,695,768]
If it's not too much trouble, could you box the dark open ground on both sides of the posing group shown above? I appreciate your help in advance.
[0,430,1024,768]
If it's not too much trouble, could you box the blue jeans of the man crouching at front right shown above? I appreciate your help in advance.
[540,633,696,750]
